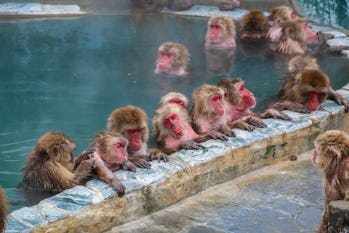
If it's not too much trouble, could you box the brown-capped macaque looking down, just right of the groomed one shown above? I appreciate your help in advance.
[107,105,168,168]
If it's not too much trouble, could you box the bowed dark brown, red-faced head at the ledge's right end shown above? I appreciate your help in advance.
[293,70,330,111]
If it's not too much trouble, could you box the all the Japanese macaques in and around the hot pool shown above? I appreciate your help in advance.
[0,6,349,232]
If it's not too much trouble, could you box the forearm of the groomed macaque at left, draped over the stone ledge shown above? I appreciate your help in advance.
[94,158,125,197]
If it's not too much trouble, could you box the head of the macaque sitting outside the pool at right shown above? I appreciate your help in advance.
[312,130,349,174]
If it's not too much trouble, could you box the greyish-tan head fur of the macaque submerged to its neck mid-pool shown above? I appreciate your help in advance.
[157,42,190,70]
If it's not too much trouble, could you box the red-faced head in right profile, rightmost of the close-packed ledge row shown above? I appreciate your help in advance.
[217,78,256,110]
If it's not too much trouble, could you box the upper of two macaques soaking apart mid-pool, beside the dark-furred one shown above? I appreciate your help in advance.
[205,16,236,49]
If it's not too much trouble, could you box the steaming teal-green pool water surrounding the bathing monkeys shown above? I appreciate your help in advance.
[0,14,349,210]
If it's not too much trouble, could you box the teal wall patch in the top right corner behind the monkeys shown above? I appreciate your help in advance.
[296,0,349,29]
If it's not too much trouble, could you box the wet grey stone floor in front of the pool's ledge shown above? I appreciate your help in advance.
[107,152,323,233]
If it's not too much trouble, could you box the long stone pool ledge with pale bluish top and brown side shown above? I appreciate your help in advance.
[5,85,349,233]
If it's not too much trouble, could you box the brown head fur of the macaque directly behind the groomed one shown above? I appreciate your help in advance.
[107,105,149,142]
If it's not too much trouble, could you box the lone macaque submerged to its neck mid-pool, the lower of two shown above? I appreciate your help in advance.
[155,42,190,76]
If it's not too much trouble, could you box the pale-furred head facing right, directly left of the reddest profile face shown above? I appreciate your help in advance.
[193,84,224,119]
